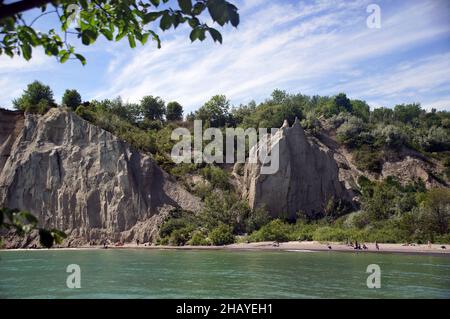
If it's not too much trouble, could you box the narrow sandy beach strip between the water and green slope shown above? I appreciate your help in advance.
[0,241,450,257]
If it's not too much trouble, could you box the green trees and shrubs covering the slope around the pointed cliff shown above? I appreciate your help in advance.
[7,83,450,245]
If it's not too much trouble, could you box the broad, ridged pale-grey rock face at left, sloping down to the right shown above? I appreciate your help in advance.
[0,108,200,244]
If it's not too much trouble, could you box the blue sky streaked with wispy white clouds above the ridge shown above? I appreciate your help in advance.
[0,0,450,114]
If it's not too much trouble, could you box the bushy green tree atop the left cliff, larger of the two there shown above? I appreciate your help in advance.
[13,81,55,113]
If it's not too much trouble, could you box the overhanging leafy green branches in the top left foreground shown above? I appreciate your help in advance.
[0,0,239,64]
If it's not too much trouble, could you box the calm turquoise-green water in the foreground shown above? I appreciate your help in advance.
[0,249,450,298]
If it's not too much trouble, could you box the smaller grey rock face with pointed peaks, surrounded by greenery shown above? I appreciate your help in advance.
[244,120,353,217]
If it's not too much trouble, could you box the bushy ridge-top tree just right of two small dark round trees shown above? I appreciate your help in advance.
[195,95,230,127]
